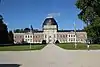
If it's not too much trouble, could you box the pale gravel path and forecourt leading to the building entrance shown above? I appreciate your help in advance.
[0,44,100,67]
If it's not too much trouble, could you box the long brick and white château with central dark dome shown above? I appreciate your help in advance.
[14,17,87,43]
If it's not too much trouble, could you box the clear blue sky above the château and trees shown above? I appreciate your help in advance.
[0,0,84,30]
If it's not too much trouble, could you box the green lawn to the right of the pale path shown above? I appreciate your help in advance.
[57,44,100,50]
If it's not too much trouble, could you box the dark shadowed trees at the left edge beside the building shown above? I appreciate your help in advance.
[0,15,14,45]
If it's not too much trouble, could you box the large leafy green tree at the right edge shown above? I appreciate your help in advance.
[76,0,100,43]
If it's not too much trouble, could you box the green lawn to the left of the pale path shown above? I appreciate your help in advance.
[0,45,46,51]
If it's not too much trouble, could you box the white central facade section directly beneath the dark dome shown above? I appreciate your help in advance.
[43,25,57,43]
